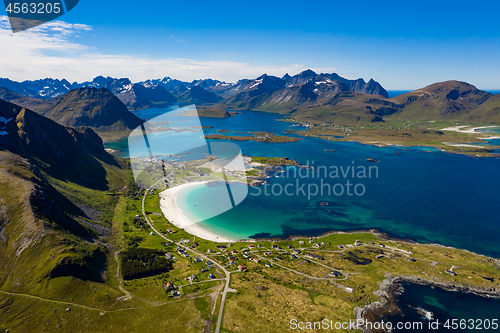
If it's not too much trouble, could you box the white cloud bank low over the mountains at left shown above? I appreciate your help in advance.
[0,16,334,82]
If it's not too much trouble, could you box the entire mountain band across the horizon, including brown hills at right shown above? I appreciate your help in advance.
[0,70,500,130]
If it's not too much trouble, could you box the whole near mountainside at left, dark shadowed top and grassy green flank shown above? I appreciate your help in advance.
[0,100,132,294]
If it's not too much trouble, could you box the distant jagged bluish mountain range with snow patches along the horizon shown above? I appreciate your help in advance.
[0,70,388,110]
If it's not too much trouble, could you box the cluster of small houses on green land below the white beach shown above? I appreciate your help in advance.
[149,231,426,297]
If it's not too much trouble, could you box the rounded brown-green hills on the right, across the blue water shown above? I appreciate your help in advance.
[284,80,500,125]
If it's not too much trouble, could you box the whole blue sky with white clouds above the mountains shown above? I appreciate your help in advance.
[0,0,500,90]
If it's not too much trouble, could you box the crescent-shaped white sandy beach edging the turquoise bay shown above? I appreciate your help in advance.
[160,182,236,243]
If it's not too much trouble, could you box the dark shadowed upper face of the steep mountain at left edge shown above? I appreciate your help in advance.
[0,100,115,188]
